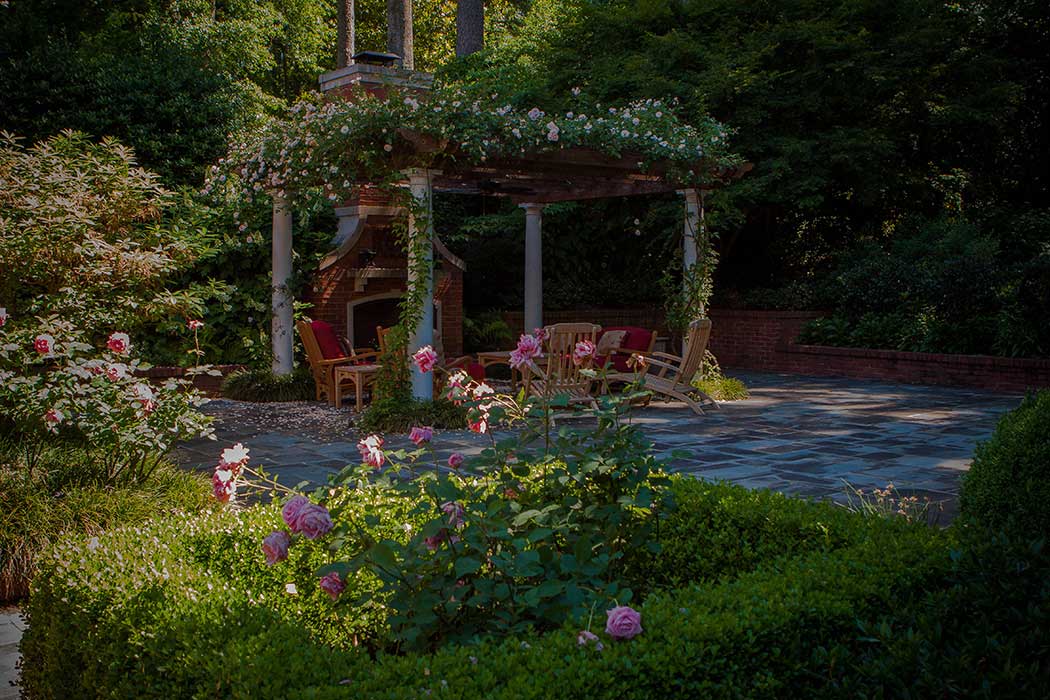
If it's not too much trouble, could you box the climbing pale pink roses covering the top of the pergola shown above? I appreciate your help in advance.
[205,87,739,215]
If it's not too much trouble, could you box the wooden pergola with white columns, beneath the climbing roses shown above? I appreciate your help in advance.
[266,65,752,399]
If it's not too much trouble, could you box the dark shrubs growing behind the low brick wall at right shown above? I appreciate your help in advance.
[800,214,1050,356]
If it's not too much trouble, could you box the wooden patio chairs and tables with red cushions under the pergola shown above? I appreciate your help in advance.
[296,319,717,415]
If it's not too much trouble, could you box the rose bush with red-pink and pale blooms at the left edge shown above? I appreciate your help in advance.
[0,316,211,484]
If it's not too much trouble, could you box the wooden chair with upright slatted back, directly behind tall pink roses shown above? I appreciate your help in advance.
[525,323,602,408]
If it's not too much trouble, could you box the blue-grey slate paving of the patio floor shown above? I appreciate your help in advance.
[179,373,1021,516]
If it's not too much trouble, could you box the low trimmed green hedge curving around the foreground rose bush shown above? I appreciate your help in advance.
[22,479,950,698]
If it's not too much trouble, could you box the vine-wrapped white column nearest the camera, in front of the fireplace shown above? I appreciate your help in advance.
[405,169,434,401]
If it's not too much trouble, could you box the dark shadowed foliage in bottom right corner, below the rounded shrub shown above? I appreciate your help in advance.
[825,531,1050,700]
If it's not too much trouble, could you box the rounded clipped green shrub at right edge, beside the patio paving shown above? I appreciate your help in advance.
[960,390,1050,537]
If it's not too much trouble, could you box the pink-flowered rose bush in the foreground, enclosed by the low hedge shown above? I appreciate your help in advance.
[238,336,672,650]
